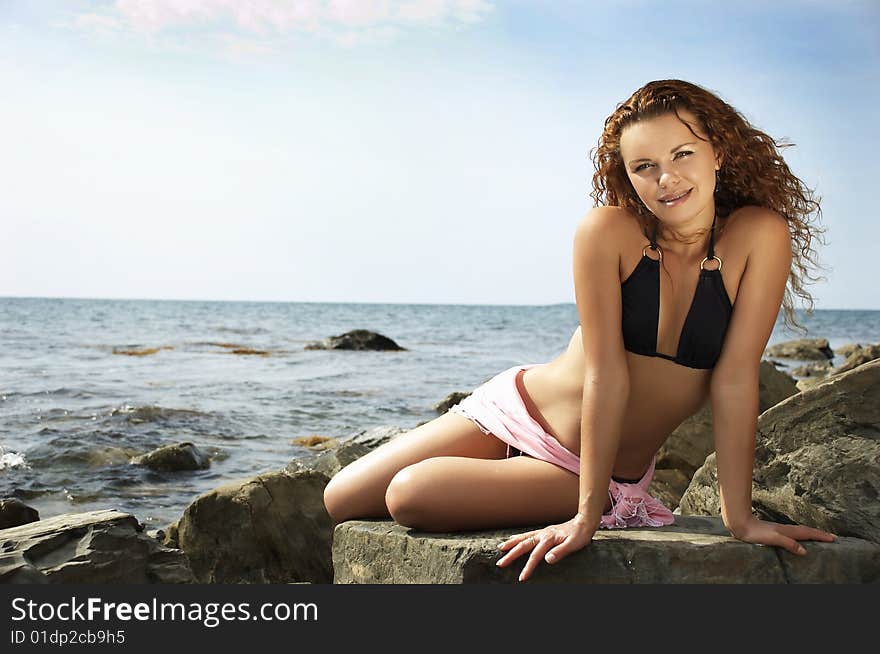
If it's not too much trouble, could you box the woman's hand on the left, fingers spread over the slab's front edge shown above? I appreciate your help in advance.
[496,513,598,581]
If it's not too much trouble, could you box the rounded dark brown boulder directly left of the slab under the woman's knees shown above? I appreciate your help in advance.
[167,470,332,584]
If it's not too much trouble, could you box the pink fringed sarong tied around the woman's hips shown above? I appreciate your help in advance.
[449,363,675,529]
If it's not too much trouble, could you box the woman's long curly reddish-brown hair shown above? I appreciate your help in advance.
[590,80,824,331]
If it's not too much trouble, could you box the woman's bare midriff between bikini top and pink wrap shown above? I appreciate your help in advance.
[522,327,711,479]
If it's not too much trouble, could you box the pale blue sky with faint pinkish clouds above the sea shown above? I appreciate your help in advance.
[0,0,880,309]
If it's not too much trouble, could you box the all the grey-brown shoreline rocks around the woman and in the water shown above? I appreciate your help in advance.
[0,331,880,584]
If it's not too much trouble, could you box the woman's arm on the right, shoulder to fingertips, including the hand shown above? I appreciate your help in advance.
[710,207,835,554]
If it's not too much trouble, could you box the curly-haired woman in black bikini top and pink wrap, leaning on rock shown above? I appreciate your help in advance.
[324,80,835,581]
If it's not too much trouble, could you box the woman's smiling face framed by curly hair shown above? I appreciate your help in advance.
[620,111,720,229]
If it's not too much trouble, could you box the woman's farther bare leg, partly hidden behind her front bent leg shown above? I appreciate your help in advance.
[324,412,507,523]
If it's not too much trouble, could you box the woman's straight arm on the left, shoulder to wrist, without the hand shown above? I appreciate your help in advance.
[573,207,629,531]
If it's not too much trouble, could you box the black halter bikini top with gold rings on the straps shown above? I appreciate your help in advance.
[620,218,733,369]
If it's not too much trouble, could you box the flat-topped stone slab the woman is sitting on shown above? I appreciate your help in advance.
[333,516,880,584]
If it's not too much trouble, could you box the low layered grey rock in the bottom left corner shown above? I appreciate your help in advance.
[0,510,194,584]
